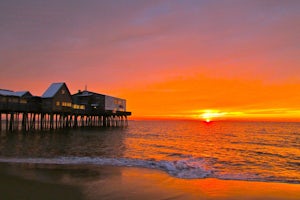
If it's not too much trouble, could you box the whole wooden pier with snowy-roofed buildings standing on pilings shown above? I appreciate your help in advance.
[0,83,131,131]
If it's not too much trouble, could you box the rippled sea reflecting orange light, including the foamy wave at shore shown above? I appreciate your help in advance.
[0,121,300,184]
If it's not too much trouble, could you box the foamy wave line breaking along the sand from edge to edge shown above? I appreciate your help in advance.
[0,157,300,183]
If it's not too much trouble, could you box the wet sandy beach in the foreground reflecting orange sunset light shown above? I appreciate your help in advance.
[0,163,300,200]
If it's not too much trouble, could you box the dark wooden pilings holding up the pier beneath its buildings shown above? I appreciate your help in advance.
[0,111,130,131]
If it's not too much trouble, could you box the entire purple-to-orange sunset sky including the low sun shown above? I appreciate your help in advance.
[0,0,300,121]
